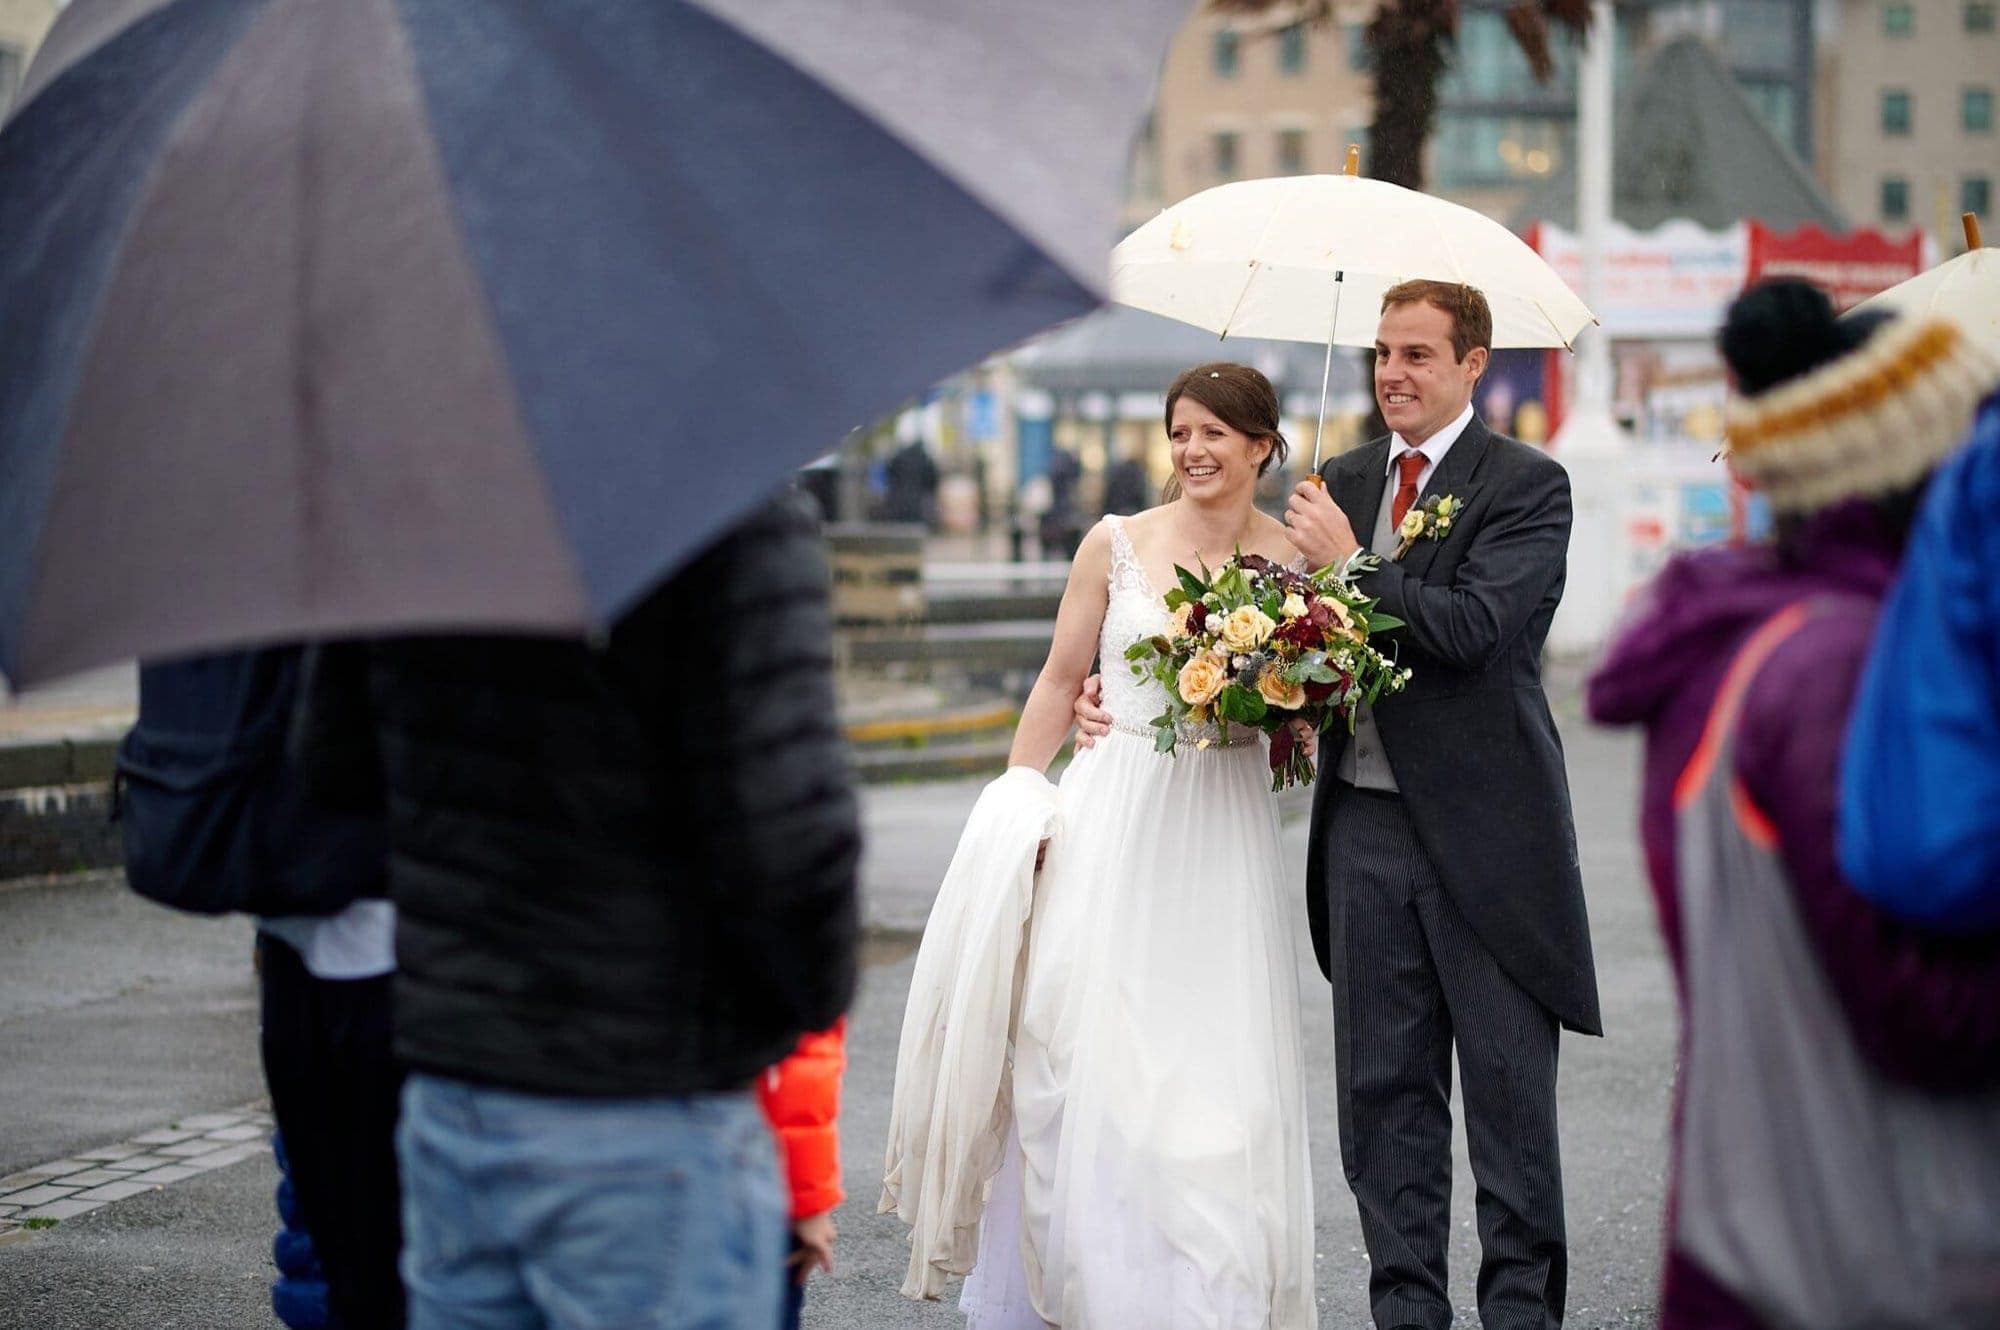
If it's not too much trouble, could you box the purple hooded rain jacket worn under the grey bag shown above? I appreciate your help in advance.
[1588,502,2000,1330]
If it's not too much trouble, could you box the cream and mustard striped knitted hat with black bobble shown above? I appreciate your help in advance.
[1724,294,2000,514]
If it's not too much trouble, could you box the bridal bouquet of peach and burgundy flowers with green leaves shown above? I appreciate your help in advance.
[1126,554,1410,790]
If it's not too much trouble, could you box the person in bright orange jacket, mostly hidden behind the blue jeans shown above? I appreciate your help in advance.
[758,1016,848,1330]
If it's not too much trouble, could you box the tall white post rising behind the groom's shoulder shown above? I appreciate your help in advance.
[1548,0,1632,654]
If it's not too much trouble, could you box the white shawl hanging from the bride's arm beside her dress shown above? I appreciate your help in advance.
[878,766,1058,1298]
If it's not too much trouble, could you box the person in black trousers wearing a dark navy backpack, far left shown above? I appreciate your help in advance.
[118,646,404,1330]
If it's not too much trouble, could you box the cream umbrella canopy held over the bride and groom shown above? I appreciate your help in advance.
[1112,176,1594,346]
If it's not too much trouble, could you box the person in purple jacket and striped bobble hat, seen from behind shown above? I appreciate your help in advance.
[1588,280,2000,1330]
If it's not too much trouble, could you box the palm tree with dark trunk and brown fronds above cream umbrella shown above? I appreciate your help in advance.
[1208,0,1590,190]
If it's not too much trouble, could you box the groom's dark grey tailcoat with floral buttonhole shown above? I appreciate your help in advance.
[1306,416,1604,1034]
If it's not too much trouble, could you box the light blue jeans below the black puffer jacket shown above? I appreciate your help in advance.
[396,1074,786,1330]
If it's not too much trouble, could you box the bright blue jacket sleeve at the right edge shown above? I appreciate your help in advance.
[1840,398,2000,932]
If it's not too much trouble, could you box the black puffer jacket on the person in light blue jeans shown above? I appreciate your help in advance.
[296,496,860,1096]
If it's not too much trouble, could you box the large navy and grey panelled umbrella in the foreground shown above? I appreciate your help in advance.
[0,0,1188,682]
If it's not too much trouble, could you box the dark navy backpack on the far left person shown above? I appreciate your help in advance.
[114,646,388,914]
